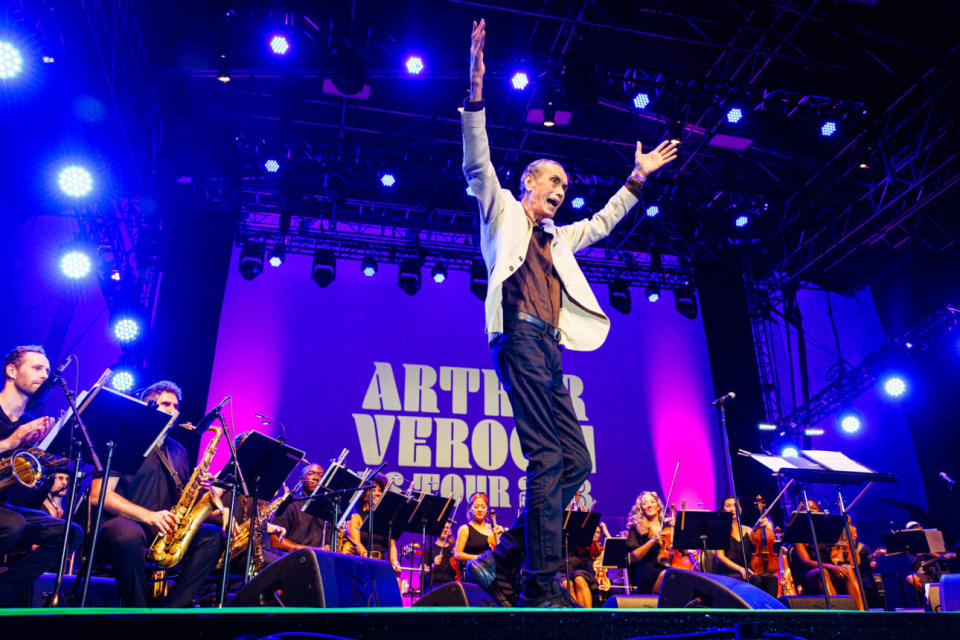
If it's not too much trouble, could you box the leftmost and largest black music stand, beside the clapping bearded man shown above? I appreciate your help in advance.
[47,386,178,607]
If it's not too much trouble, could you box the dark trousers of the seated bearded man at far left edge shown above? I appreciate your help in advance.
[0,504,83,605]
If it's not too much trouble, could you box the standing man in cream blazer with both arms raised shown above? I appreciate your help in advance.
[463,20,676,607]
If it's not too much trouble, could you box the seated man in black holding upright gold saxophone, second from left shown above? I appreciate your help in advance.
[90,380,224,607]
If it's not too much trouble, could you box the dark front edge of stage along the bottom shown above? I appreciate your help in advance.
[0,607,960,640]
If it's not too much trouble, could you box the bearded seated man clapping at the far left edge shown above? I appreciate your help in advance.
[0,346,83,606]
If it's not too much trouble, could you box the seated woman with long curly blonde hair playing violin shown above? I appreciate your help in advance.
[626,491,671,593]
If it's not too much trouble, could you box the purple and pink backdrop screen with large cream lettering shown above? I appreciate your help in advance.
[209,248,723,526]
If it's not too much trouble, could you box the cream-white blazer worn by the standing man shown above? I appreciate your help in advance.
[462,111,637,351]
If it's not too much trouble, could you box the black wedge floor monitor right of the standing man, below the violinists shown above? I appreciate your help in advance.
[657,569,786,609]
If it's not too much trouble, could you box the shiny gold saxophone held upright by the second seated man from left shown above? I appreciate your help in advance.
[148,427,223,569]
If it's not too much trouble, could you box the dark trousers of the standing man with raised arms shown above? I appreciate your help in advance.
[491,321,592,597]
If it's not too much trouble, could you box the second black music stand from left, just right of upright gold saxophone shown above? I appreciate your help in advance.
[221,431,304,584]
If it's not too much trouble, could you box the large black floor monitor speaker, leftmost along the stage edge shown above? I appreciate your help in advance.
[230,549,403,608]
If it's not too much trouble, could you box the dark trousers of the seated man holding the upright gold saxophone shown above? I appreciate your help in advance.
[97,516,224,607]
